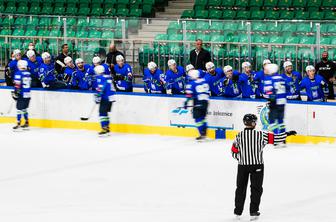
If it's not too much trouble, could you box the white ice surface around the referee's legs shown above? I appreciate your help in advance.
[0,124,336,222]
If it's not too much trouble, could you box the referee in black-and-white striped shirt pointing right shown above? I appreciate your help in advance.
[231,114,296,220]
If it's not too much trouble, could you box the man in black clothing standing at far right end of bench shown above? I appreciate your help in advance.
[315,52,336,99]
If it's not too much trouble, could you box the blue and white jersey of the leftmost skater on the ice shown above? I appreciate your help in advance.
[14,70,31,98]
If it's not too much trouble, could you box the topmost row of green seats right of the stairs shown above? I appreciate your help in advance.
[194,0,336,10]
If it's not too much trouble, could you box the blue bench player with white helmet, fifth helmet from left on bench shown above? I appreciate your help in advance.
[73,58,90,90]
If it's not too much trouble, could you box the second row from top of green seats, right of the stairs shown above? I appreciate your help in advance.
[181,9,336,20]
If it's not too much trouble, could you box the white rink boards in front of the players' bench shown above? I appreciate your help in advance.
[0,88,336,137]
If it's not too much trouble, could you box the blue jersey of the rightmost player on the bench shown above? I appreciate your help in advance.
[300,75,329,101]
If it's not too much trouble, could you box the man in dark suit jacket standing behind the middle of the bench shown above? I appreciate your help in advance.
[190,39,211,70]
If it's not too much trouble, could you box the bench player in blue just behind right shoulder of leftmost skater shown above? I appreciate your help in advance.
[25,50,43,88]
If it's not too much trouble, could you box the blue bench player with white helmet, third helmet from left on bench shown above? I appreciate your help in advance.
[39,52,67,89]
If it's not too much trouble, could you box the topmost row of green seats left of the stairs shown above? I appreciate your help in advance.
[0,2,153,17]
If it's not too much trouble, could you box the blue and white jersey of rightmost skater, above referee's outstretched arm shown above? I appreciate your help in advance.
[264,74,287,105]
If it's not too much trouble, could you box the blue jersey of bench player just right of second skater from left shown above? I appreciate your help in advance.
[114,63,133,90]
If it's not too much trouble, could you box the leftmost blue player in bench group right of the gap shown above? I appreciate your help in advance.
[143,62,167,94]
